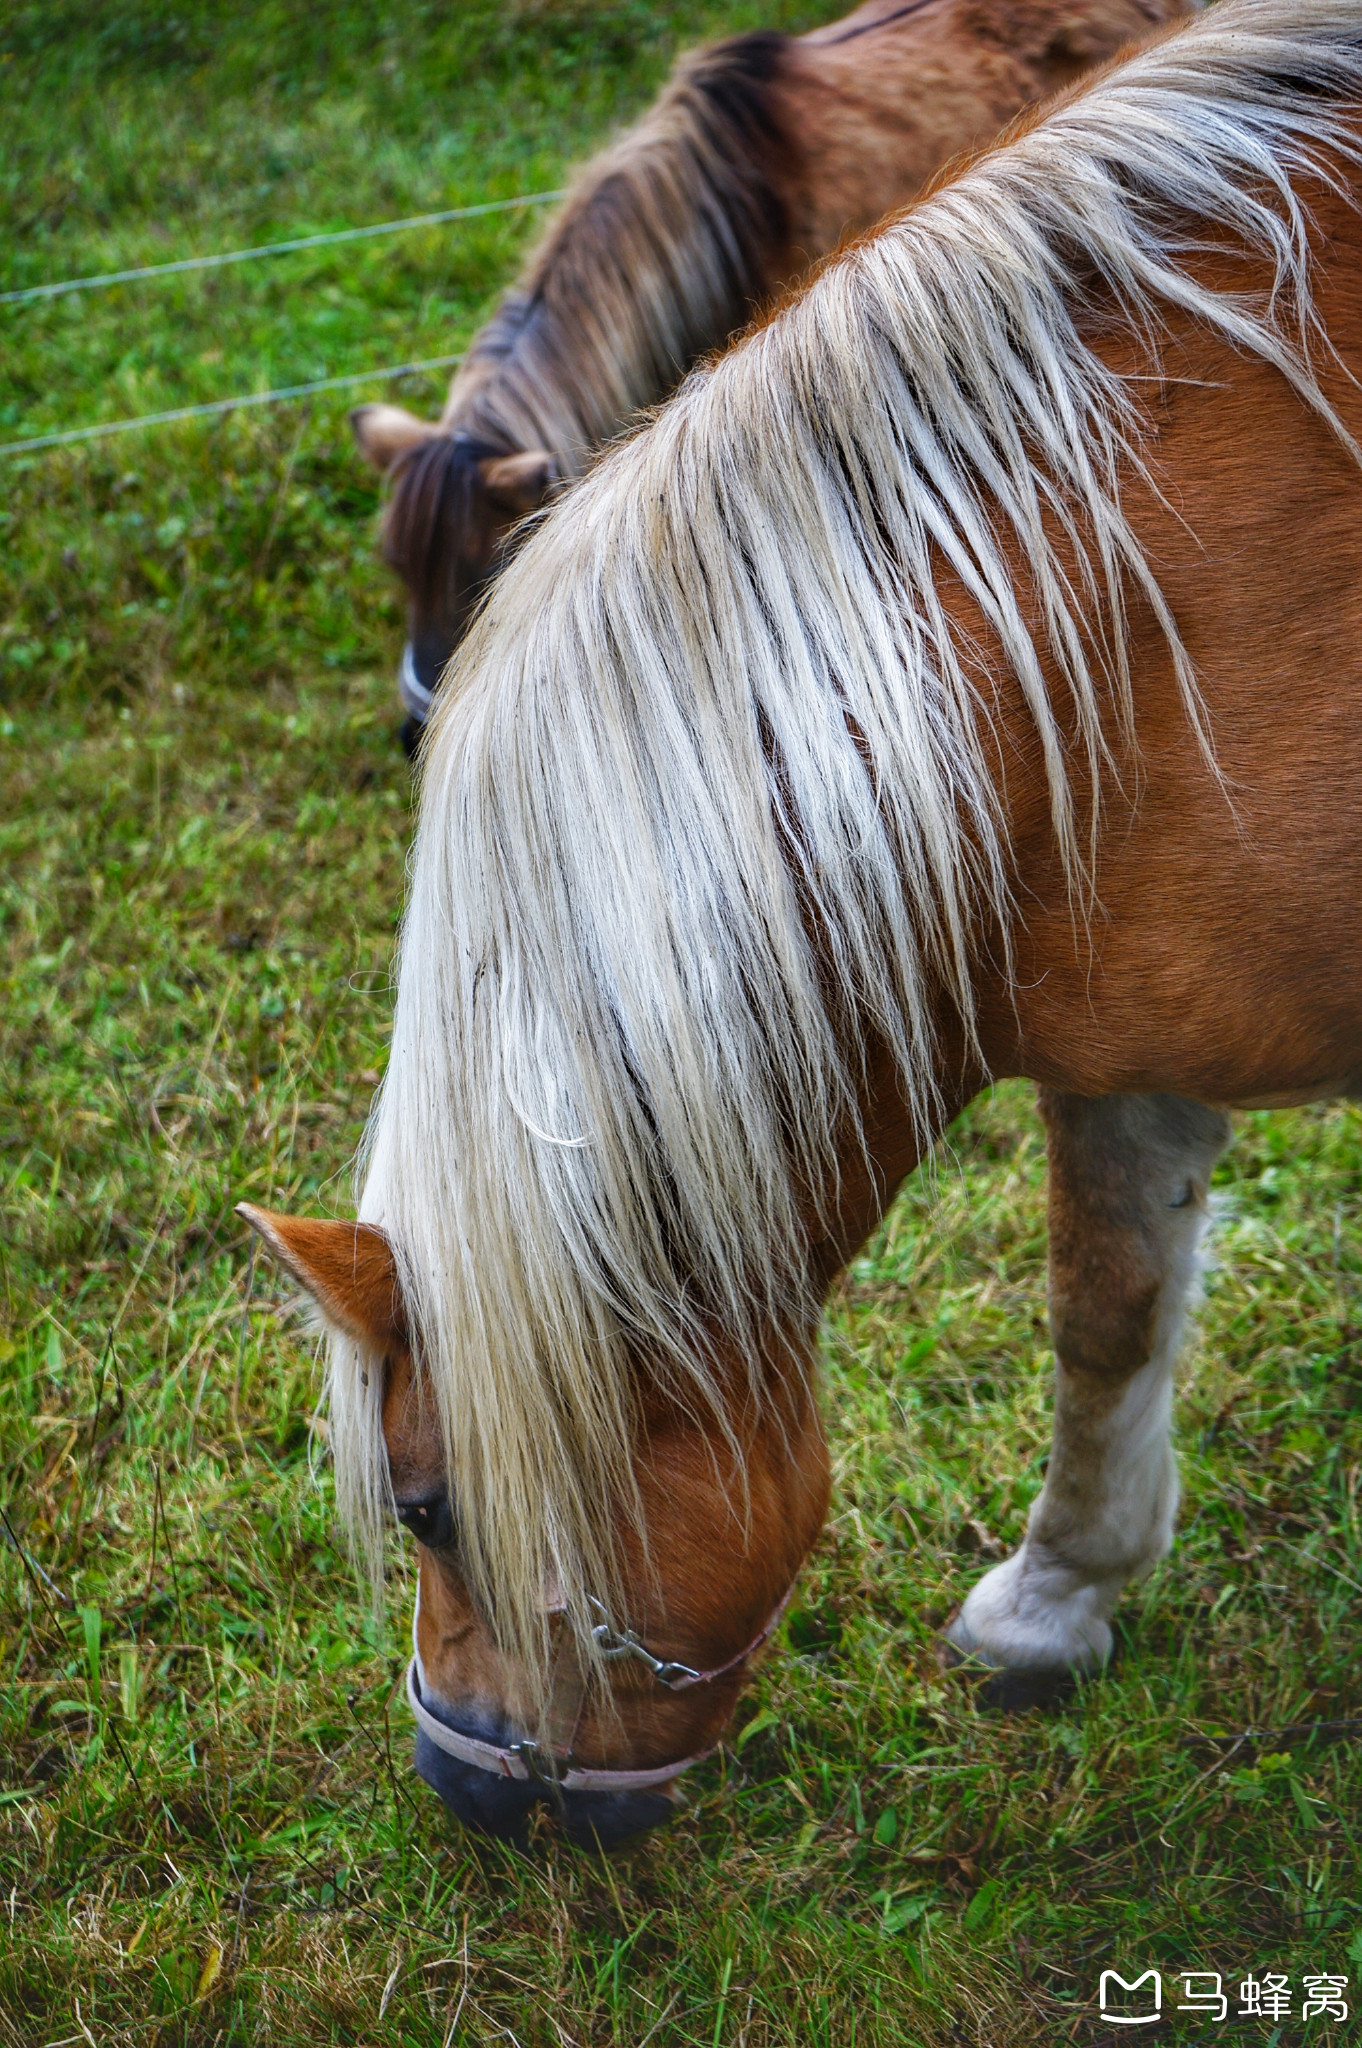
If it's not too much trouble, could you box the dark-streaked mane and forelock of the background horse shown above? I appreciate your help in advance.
[374,31,801,704]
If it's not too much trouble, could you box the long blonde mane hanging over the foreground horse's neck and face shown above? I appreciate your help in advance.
[332,0,1362,1695]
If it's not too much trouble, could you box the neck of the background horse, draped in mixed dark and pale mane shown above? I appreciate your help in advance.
[444,37,803,475]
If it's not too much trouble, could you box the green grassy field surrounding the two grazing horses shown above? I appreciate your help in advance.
[0,0,1362,2048]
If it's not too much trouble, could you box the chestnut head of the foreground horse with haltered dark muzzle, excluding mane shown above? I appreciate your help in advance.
[242,1204,829,1847]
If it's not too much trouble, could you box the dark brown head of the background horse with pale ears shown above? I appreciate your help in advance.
[350,406,559,741]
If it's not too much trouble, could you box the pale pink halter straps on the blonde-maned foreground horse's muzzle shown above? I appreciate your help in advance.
[408,1583,795,1792]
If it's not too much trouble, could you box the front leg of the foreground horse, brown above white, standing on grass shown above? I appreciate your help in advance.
[948,1090,1229,1673]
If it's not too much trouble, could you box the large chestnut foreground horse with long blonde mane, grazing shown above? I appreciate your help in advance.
[248,0,1362,1839]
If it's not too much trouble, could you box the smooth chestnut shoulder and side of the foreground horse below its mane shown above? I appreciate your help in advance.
[948,144,1362,1106]
